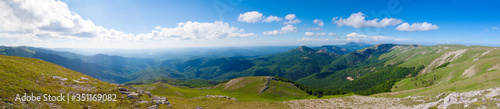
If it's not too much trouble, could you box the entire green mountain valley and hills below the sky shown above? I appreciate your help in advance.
[0,43,500,109]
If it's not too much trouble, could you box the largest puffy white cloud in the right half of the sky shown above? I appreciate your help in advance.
[332,12,403,28]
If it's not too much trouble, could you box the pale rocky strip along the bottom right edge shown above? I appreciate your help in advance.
[284,87,500,109]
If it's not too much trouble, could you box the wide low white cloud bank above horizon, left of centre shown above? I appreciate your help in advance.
[137,21,256,40]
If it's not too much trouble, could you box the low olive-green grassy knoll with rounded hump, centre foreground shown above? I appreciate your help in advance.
[133,77,310,101]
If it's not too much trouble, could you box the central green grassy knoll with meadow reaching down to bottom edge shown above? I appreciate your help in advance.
[134,77,315,108]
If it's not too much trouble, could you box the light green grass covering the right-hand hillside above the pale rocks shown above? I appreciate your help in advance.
[372,46,500,97]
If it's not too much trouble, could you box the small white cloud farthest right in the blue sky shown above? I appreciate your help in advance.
[396,22,439,32]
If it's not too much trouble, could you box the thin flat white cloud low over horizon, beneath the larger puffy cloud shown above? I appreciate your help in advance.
[346,32,409,42]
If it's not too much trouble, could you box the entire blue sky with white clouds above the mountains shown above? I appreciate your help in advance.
[0,0,500,49]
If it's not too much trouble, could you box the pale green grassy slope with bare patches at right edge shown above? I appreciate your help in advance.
[374,45,500,97]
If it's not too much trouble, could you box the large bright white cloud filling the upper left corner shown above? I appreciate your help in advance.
[0,0,133,38]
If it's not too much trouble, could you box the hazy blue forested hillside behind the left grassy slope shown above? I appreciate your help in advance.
[0,46,153,83]
